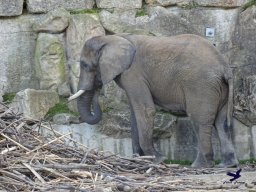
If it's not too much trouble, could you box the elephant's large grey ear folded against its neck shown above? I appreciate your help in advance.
[99,36,135,85]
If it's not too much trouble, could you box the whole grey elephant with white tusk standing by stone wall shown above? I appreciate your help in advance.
[69,34,238,167]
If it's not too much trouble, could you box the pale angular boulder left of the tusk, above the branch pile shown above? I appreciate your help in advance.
[12,89,59,120]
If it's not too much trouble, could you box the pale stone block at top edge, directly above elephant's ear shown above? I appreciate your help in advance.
[96,0,142,9]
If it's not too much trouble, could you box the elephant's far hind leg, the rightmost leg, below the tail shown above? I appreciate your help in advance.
[215,104,238,167]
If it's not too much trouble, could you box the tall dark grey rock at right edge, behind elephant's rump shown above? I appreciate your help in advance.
[231,6,256,126]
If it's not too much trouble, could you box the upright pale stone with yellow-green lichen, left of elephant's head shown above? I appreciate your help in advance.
[35,33,66,90]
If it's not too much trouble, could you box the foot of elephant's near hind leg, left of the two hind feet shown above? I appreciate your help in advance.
[191,153,214,168]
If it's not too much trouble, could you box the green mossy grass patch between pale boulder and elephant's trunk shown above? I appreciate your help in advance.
[45,98,78,119]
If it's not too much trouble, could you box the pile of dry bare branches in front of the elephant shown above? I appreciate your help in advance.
[0,103,256,192]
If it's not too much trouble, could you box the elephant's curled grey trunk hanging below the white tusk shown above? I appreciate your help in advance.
[77,91,102,125]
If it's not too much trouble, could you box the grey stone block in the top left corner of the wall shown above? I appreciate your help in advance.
[0,0,24,16]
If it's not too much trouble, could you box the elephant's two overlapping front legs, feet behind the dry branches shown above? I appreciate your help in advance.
[121,79,163,162]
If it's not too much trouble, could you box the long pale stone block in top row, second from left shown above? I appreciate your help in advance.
[26,0,95,13]
